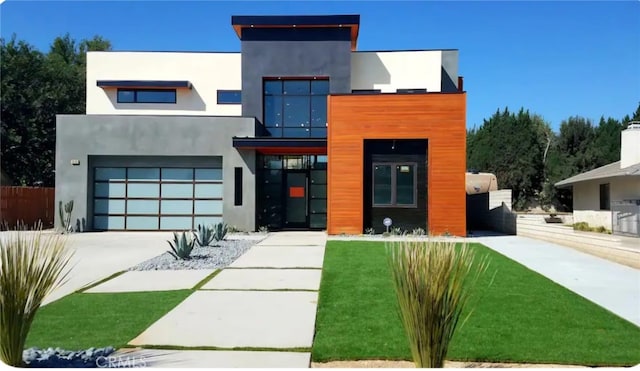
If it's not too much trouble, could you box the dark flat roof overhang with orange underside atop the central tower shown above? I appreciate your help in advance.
[231,14,360,51]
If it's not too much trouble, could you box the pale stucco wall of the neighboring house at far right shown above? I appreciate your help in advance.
[573,176,640,230]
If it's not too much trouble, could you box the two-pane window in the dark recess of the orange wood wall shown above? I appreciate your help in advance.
[372,162,417,207]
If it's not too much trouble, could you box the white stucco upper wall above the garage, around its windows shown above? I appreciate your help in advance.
[87,52,242,116]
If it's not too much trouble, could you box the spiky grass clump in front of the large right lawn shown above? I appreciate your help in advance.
[387,239,487,368]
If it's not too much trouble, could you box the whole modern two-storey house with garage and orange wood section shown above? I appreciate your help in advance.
[56,15,466,235]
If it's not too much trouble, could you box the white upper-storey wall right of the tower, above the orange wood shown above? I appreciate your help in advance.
[351,50,442,93]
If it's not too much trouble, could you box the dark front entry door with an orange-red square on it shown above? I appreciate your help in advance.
[285,170,309,228]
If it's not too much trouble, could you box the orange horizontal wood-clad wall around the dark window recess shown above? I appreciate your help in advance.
[327,93,467,236]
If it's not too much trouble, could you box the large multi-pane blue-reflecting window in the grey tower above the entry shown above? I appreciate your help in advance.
[263,79,329,138]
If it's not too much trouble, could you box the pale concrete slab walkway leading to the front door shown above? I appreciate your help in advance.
[118,232,326,368]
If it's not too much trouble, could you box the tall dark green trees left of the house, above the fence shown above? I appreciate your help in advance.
[0,34,111,186]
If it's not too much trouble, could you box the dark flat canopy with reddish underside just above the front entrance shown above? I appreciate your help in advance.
[233,137,327,155]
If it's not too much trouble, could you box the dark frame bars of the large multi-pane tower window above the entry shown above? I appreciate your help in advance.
[262,76,331,138]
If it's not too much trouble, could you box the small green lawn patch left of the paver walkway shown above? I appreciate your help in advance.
[26,290,193,350]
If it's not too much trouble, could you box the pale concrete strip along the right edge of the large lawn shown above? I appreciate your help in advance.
[468,236,640,326]
